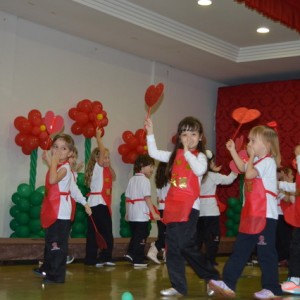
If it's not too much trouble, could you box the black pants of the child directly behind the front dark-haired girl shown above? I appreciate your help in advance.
[197,216,220,264]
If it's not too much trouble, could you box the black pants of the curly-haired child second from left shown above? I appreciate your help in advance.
[84,204,114,265]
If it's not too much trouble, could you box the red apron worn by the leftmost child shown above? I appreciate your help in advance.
[41,162,75,228]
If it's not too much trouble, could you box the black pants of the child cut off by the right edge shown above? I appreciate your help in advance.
[289,227,300,277]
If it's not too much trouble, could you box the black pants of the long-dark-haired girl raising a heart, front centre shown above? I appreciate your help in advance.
[166,209,219,295]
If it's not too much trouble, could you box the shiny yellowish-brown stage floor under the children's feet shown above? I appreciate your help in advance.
[0,257,300,300]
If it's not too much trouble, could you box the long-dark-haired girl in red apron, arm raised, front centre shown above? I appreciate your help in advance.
[145,117,219,296]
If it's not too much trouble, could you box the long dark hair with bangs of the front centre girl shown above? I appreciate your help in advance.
[167,117,206,178]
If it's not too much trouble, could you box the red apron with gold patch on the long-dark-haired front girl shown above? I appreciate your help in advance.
[163,149,200,224]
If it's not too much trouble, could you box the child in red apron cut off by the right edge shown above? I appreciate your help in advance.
[279,145,300,295]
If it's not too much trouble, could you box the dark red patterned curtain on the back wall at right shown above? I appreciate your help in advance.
[216,80,300,235]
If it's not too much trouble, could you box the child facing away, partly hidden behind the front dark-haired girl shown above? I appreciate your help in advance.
[197,150,237,265]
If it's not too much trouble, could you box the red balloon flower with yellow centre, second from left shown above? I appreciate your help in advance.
[69,99,108,138]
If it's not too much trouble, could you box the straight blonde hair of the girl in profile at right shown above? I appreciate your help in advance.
[249,125,281,167]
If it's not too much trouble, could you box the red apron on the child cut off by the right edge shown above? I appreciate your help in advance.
[280,172,300,227]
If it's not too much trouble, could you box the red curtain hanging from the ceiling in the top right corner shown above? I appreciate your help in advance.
[236,0,300,32]
